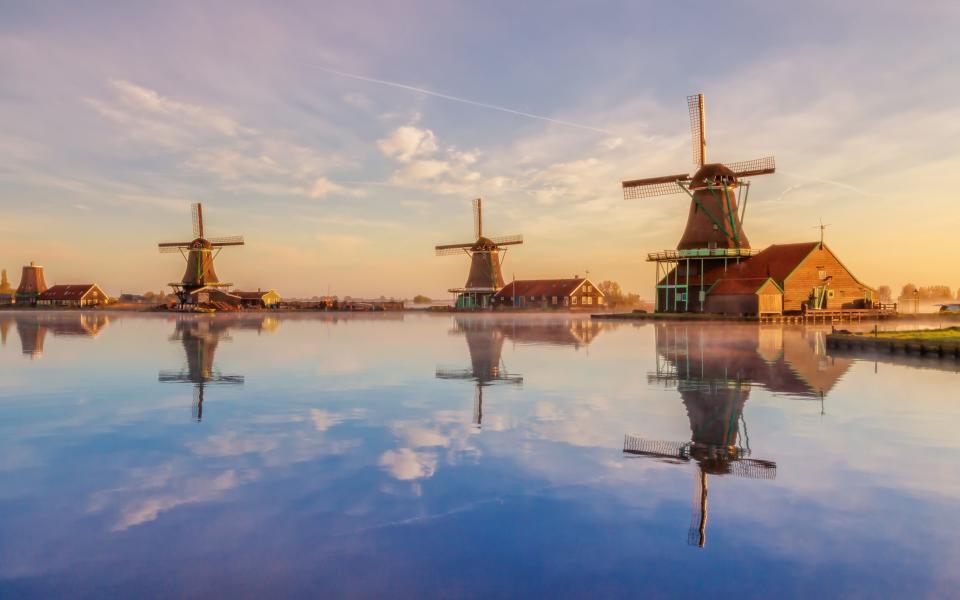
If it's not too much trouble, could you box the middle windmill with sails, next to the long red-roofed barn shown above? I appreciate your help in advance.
[435,198,523,308]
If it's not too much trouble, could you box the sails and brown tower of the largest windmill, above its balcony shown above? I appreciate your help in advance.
[622,94,776,250]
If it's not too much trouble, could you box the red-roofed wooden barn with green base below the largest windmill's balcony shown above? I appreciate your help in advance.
[657,242,874,315]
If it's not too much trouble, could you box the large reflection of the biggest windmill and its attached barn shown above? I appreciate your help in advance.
[623,323,851,547]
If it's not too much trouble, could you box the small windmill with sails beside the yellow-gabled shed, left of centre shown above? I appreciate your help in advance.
[158,202,244,304]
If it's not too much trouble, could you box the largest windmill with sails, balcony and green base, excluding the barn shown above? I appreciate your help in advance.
[622,94,776,312]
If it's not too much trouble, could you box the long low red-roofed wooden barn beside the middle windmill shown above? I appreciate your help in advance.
[492,277,604,310]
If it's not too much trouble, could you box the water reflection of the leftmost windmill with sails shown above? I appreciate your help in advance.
[158,317,246,423]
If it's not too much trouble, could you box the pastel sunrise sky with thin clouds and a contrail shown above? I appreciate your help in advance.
[0,0,960,298]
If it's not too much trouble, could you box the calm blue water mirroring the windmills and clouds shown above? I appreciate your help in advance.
[0,312,960,598]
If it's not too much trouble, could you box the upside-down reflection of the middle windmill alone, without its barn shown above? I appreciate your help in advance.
[436,319,523,427]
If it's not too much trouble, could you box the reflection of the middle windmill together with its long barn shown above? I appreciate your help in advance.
[436,316,606,427]
